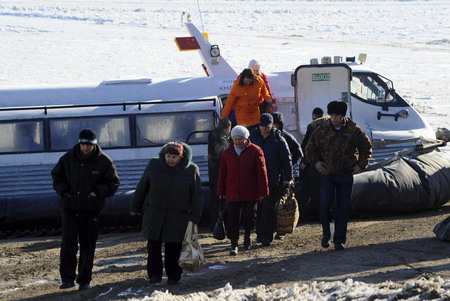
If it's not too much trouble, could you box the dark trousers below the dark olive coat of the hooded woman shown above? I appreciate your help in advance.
[147,240,183,281]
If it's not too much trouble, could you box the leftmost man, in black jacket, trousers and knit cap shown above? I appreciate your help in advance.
[52,129,119,290]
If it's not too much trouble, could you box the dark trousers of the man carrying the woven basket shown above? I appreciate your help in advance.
[256,182,283,242]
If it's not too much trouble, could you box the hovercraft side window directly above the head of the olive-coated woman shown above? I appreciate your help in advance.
[136,112,214,146]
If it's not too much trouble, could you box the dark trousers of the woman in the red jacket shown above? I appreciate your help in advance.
[227,201,256,241]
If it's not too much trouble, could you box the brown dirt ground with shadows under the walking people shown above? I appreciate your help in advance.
[0,204,450,300]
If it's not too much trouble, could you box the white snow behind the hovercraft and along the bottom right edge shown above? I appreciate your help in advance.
[0,0,450,300]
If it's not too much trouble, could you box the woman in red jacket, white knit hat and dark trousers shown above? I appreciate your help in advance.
[217,125,269,255]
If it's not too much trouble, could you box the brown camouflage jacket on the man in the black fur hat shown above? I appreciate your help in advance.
[306,117,372,175]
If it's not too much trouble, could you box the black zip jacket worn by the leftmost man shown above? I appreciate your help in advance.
[51,144,120,213]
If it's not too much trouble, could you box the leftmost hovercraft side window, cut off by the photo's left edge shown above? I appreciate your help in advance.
[0,121,44,153]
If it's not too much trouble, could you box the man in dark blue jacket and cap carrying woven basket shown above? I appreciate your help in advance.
[250,113,293,246]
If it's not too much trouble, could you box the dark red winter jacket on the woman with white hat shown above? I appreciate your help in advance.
[217,140,269,202]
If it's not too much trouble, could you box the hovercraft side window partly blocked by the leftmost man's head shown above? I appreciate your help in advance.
[50,116,131,150]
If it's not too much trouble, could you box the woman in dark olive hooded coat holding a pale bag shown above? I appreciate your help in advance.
[131,142,203,285]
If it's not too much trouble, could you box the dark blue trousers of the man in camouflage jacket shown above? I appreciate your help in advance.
[320,173,353,243]
